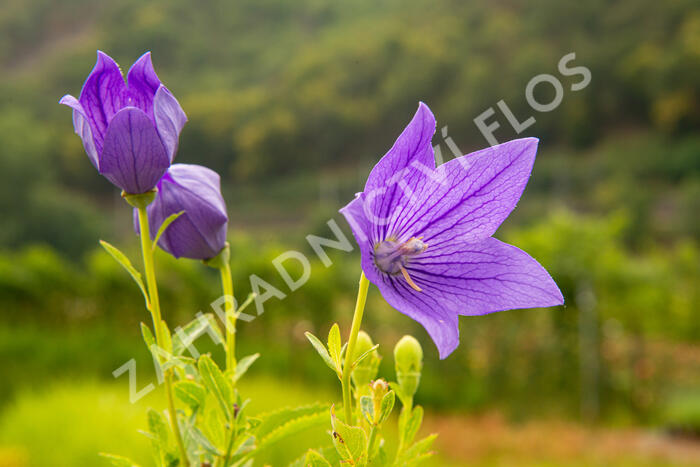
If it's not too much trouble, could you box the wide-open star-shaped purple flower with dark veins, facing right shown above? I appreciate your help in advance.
[340,103,564,358]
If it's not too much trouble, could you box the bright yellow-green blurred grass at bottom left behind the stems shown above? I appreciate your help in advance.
[0,377,333,467]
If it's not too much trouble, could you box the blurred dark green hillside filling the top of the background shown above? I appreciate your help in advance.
[0,0,700,254]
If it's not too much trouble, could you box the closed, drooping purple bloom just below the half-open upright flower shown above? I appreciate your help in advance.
[140,164,228,260]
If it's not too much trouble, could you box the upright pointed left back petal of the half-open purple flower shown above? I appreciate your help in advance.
[80,51,127,154]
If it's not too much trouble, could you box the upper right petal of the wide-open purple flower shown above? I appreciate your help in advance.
[387,138,538,247]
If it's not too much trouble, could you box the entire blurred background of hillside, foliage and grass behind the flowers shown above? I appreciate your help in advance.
[0,0,700,467]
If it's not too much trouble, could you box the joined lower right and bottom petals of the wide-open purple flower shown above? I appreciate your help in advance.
[372,237,564,359]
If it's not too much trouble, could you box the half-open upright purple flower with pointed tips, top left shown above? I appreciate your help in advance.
[60,51,187,194]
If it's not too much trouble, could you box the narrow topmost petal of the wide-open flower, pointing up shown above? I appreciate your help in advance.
[364,102,435,241]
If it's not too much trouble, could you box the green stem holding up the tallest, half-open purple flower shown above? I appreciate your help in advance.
[138,206,189,467]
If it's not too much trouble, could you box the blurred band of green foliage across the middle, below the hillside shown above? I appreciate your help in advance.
[0,210,700,422]
